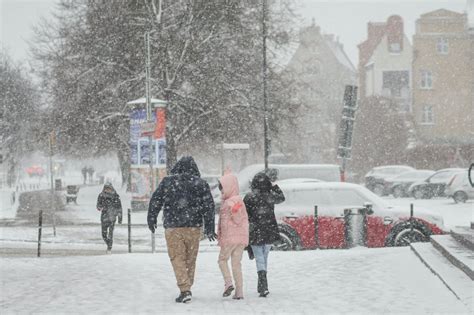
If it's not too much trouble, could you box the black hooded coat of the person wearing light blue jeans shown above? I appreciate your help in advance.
[244,172,285,245]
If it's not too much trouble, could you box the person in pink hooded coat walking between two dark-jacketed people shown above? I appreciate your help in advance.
[217,172,249,300]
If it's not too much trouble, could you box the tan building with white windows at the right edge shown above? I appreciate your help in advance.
[413,9,474,146]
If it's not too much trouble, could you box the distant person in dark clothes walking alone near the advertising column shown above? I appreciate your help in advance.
[97,182,122,254]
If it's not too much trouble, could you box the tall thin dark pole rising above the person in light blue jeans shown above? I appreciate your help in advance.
[262,0,270,170]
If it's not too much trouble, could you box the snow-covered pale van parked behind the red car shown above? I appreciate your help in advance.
[237,164,341,195]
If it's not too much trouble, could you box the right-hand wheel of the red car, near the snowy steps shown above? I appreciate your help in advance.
[385,221,431,246]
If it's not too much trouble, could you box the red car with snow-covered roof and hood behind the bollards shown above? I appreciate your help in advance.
[274,182,443,250]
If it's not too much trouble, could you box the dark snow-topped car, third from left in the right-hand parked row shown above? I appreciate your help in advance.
[408,168,467,199]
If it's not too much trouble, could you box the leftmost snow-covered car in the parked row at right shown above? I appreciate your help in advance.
[365,165,415,196]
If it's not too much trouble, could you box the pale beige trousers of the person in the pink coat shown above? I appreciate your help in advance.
[218,245,245,296]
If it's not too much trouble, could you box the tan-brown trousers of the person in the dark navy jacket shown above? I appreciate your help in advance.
[165,227,201,292]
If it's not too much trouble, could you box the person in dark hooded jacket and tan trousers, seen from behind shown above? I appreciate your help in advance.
[148,156,216,303]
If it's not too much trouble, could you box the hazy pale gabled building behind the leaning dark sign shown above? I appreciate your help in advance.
[274,21,356,163]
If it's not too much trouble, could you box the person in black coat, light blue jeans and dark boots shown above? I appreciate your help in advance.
[244,172,285,297]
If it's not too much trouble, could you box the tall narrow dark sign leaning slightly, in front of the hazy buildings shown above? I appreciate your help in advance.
[337,85,357,159]
